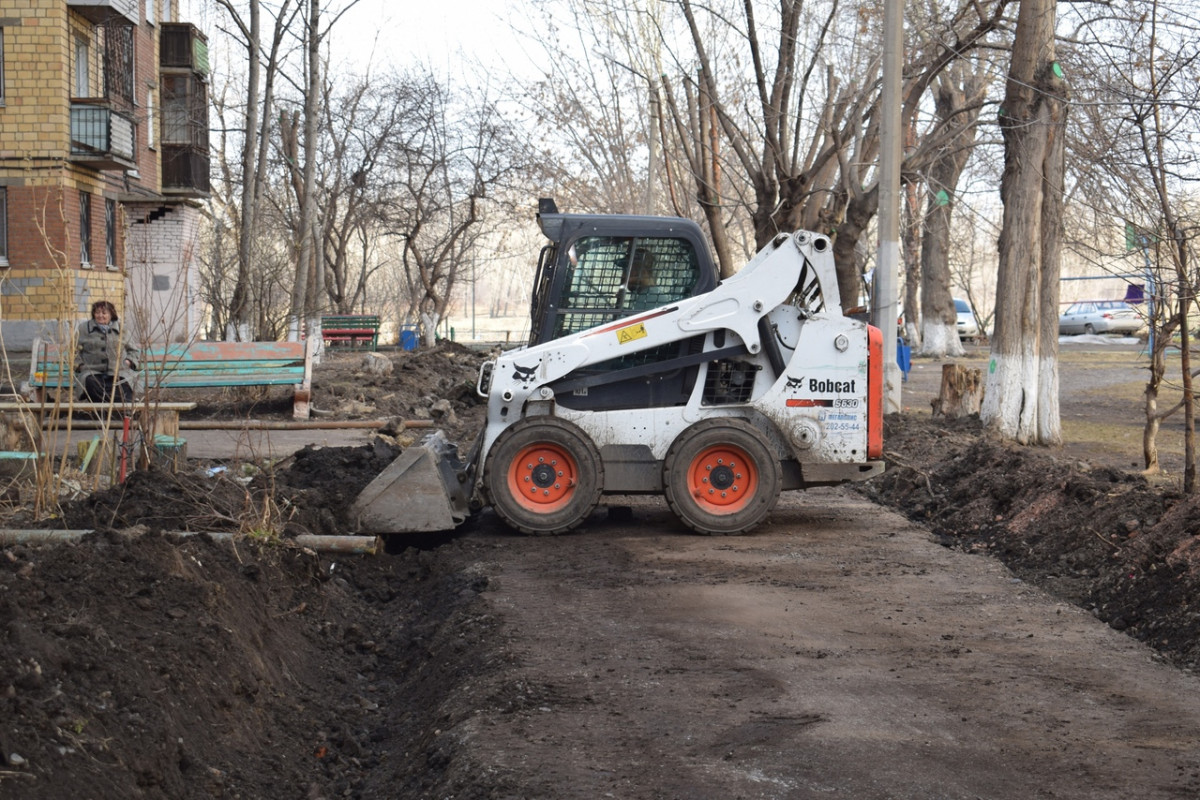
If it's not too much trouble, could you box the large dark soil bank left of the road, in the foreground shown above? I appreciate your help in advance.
[0,533,494,800]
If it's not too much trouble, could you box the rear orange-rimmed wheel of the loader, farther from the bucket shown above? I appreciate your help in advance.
[662,417,784,536]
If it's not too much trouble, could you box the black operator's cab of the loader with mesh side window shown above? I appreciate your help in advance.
[529,200,719,345]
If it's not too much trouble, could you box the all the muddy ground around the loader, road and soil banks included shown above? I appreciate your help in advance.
[0,344,1200,800]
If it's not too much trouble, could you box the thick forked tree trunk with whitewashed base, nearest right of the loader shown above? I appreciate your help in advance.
[980,0,1067,445]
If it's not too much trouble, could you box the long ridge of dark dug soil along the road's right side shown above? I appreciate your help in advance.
[864,415,1200,669]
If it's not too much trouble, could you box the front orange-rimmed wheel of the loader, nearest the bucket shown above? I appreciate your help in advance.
[484,416,604,536]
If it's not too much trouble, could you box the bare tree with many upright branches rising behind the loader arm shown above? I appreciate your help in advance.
[671,0,1007,299]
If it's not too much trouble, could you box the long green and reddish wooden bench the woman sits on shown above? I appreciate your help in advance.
[29,339,316,420]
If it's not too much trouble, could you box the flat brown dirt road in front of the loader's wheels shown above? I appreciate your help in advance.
[440,491,1200,800]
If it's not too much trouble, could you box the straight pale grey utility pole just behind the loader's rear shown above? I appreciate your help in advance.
[871,0,904,414]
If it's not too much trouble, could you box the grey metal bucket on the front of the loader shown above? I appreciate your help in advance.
[350,431,470,534]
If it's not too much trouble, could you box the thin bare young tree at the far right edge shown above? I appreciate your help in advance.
[1073,0,1200,493]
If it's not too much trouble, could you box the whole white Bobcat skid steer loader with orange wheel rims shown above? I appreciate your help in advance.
[353,200,883,534]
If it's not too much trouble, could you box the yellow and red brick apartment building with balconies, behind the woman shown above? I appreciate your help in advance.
[0,0,209,351]
